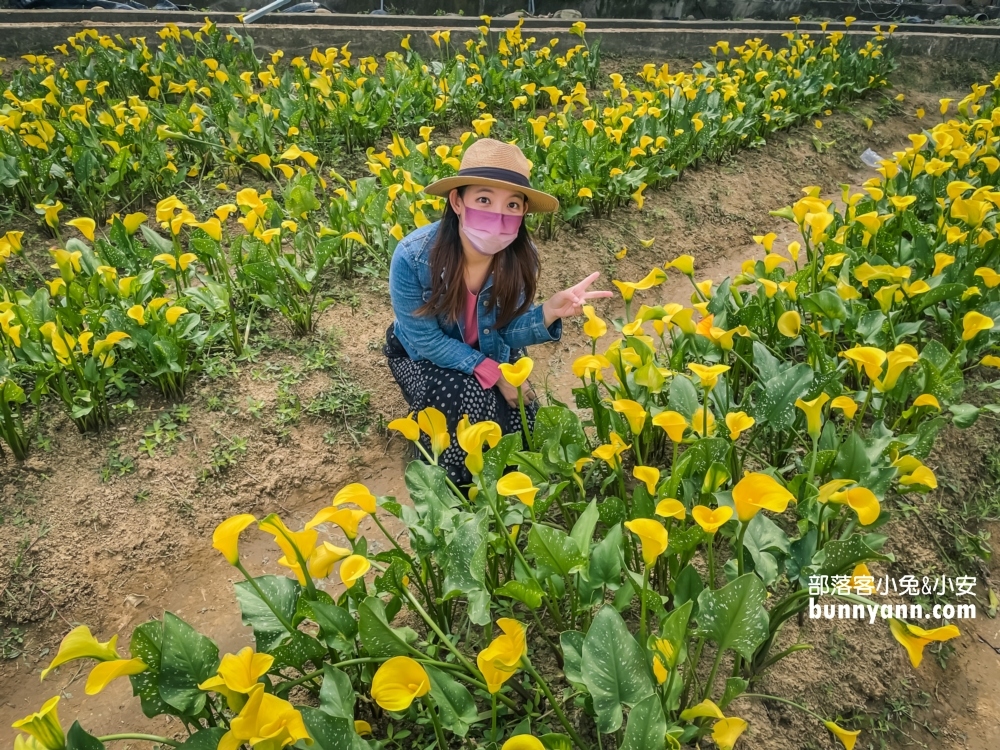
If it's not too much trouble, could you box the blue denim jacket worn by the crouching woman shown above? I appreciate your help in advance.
[389,221,562,375]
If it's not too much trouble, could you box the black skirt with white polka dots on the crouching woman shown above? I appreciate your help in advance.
[383,325,538,487]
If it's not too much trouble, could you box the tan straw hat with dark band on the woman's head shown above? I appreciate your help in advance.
[424,138,559,213]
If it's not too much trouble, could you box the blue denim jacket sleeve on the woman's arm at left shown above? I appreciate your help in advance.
[389,246,486,375]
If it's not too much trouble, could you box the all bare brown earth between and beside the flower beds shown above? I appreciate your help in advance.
[0,58,1000,750]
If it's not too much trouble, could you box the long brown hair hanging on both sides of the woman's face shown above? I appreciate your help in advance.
[417,188,540,328]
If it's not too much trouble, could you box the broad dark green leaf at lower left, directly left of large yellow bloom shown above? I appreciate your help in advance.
[160,612,219,716]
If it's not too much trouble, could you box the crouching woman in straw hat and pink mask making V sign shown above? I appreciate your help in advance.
[385,138,611,485]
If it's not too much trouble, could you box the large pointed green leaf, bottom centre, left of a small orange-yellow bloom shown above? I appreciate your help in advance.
[582,605,653,734]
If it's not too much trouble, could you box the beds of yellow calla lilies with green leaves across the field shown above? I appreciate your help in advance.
[0,13,1000,750]
